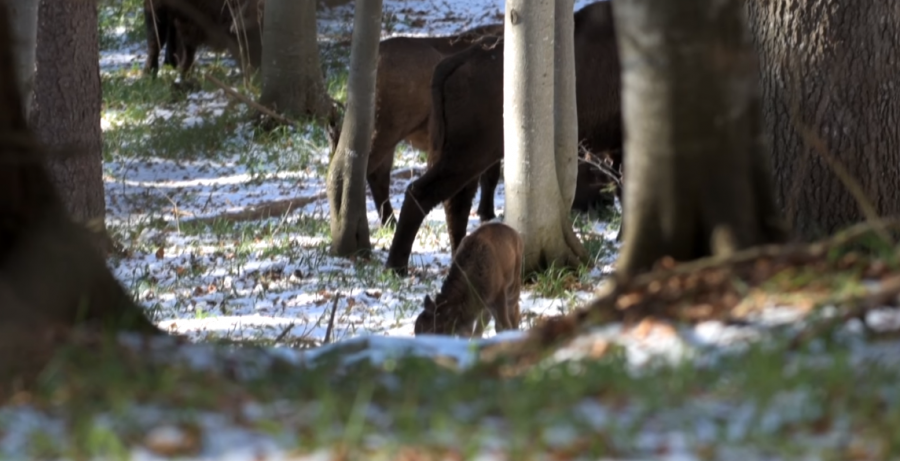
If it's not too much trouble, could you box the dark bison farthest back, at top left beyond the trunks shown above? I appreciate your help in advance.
[144,0,265,79]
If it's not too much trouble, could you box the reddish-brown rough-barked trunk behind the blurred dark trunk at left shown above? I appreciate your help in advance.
[31,0,106,229]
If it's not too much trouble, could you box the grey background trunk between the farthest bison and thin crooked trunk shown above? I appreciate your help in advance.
[259,0,332,118]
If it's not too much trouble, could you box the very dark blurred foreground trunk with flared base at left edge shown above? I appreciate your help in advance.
[0,0,161,380]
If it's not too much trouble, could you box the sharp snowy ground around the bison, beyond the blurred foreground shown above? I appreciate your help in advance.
[101,0,616,345]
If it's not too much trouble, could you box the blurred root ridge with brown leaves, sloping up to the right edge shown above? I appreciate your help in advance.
[481,220,900,374]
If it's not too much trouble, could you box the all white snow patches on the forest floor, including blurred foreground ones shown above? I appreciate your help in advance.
[0,0,900,460]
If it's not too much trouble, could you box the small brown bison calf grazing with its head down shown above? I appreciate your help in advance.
[415,222,523,338]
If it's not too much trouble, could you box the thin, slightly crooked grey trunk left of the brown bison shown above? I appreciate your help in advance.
[328,0,381,256]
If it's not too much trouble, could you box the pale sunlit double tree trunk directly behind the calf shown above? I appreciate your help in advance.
[503,0,587,273]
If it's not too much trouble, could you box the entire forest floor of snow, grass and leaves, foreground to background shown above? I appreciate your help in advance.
[0,0,900,460]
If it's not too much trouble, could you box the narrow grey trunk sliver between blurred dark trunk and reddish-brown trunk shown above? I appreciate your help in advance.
[6,0,40,119]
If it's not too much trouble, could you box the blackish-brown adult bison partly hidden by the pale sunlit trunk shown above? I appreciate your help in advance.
[387,1,622,273]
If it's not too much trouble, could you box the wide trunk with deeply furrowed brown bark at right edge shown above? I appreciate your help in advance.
[747,0,900,238]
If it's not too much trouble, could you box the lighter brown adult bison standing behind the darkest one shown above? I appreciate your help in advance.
[366,24,503,224]
